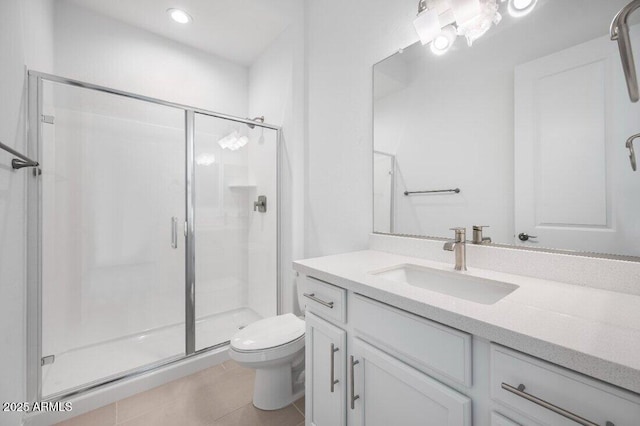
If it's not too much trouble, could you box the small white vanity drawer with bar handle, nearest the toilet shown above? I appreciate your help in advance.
[303,276,347,323]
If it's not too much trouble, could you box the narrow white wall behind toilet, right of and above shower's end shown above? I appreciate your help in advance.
[249,2,305,312]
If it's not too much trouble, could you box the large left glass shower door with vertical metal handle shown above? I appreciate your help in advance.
[39,81,186,398]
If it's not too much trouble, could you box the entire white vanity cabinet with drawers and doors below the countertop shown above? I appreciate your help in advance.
[304,277,640,426]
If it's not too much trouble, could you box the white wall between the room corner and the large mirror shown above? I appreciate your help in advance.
[305,0,417,257]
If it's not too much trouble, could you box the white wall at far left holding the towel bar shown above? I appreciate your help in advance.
[0,0,52,426]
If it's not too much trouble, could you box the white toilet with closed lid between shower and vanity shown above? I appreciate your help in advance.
[229,284,305,410]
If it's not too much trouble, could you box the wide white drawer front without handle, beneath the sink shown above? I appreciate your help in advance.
[349,294,472,387]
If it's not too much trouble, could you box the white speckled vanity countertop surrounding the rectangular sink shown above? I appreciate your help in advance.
[294,250,640,393]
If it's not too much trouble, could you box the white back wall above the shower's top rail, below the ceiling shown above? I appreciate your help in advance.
[55,0,248,117]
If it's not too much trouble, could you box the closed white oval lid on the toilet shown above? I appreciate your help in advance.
[231,314,305,351]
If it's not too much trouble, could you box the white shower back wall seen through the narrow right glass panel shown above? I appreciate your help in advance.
[195,114,252,322]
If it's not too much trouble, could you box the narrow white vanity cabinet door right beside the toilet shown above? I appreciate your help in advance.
[305,312,347,426]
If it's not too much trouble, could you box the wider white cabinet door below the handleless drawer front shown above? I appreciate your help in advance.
[348,339,471,426]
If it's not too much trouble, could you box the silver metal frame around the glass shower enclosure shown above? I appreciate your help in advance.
[25,70,282,402]
